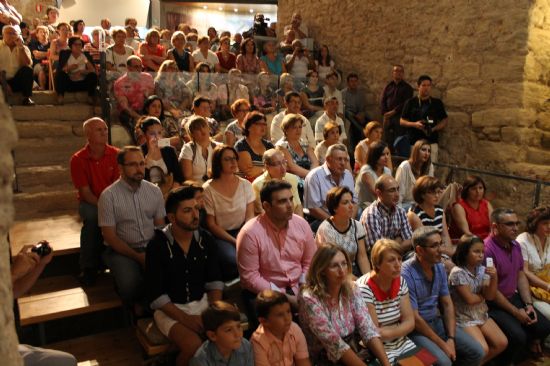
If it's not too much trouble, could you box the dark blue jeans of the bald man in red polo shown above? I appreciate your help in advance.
[78,202,105,270]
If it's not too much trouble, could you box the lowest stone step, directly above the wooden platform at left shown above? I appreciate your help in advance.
[13,189,78,221]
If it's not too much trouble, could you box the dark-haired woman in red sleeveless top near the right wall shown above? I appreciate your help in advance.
[450,175,493,239]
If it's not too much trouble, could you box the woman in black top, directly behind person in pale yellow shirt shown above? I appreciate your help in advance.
[235,111,275,182]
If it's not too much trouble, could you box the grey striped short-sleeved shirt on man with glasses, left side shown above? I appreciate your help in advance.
[97,178,166,248]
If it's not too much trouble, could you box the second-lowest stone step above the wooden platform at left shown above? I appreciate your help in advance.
[15,162,73,193]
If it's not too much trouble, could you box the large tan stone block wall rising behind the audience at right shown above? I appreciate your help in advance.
[278,0,550,210]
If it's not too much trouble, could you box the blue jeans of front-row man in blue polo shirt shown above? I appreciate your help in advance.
[409,318,485,366]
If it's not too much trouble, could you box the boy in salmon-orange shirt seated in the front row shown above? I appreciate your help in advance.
[250,290,311,366]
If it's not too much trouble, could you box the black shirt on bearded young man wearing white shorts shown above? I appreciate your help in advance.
[145,225,223,305]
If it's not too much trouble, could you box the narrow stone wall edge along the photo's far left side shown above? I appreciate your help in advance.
[0,91,23,366]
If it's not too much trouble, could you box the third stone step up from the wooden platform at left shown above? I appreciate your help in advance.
[15,135,84,167]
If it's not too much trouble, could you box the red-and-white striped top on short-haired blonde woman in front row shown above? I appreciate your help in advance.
[355,274,416,365]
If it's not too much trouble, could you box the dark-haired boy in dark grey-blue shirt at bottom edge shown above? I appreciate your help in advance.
[189,301,254,366]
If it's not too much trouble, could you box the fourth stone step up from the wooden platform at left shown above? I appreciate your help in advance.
[16,120,85,145]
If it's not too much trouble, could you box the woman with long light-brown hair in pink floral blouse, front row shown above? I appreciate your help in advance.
[298,244,390,366]
